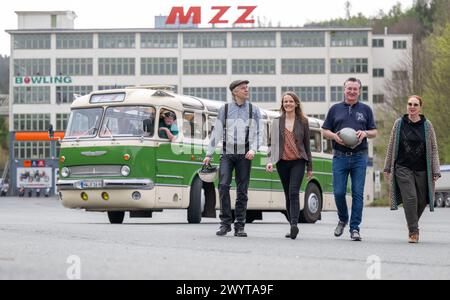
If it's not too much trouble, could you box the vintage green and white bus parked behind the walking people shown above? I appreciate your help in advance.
[57,87,370,224]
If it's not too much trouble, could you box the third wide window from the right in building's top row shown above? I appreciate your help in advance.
[232,32,276,48]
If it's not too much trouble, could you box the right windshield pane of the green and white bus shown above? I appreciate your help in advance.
[100,106,156,138]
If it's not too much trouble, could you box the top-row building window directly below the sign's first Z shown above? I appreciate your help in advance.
[183,32,227,48]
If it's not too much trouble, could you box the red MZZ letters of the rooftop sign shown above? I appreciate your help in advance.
[166,6,256,24]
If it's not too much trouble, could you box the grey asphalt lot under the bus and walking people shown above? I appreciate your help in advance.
[0,198,450,280]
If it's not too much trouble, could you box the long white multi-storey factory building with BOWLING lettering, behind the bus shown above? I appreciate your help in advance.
[8,11,412,193]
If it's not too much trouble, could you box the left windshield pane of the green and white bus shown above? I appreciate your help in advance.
[65,108,103,138]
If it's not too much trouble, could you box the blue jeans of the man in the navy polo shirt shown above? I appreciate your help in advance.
[333,152,367,232]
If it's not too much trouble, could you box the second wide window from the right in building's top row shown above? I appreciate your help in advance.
[281,31,325,47]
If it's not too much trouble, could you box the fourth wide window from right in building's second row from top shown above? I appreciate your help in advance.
[183,59,227,75]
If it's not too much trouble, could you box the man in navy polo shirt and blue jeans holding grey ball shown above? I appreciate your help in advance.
[322,78,377,241]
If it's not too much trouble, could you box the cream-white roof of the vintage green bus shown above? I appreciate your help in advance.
[71,86,323,128]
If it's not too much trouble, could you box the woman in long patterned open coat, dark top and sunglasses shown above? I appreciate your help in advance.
[384,95,441,243]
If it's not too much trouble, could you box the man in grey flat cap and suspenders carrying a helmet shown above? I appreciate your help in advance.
[203,80,262,237]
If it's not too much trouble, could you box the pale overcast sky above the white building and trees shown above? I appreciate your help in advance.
[0,0,413,55]
